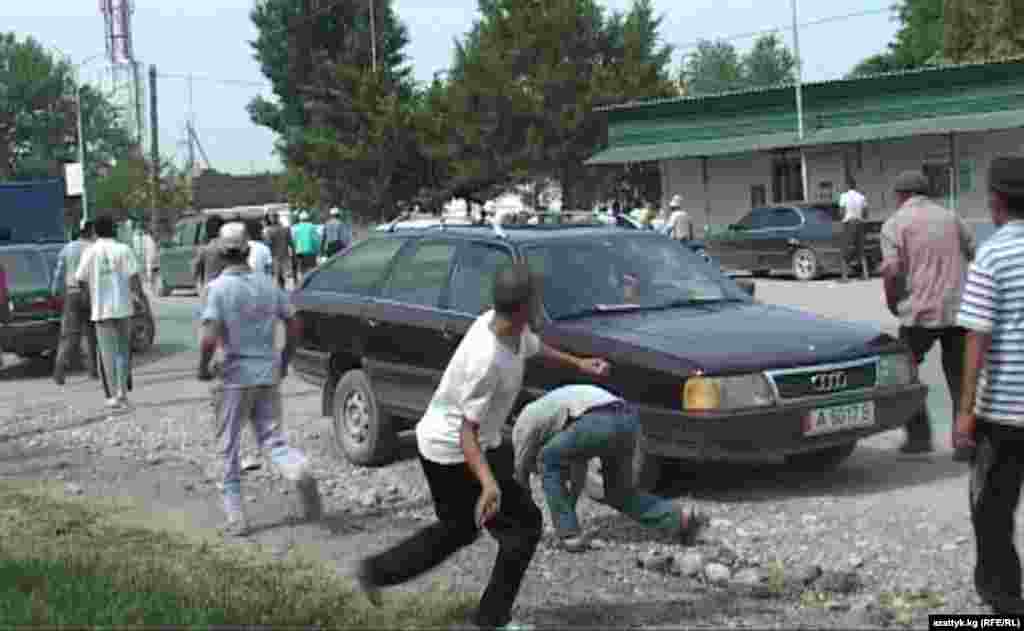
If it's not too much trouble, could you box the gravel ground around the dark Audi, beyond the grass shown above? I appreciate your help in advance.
[0,281,1003,628]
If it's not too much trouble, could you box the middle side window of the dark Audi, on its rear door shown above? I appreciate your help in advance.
[381,241,457,306]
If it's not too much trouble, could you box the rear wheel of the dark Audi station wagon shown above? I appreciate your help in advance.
[331,370,397,466]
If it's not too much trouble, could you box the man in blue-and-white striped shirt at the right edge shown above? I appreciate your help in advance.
[953,157,1024,614]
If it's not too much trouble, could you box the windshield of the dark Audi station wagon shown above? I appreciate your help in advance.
[523,232,750,320]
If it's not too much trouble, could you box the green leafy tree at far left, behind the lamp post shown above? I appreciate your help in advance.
[0,33,133,180]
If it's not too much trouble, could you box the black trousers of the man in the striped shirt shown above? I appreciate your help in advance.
[970,418,1024,611]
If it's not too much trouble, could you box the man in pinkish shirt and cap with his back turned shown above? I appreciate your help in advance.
[882,171,975,461]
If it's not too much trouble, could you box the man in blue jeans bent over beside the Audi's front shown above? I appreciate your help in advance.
[512,385,709,552]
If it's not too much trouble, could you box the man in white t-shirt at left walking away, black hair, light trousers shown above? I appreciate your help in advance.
[75,216,142,409]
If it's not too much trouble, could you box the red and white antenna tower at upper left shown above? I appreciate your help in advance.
[99,0,145,152]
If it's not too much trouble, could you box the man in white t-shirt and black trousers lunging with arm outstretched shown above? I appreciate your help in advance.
[356,264,609,628]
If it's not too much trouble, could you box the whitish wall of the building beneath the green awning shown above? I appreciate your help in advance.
[660,129,1024,231]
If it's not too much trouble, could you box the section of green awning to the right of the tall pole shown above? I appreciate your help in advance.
[801,110,1024,146]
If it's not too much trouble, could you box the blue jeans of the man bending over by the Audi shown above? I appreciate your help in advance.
[541,409,682,538]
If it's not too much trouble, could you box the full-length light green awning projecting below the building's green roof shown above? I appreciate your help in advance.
[586,110,1024,165]
